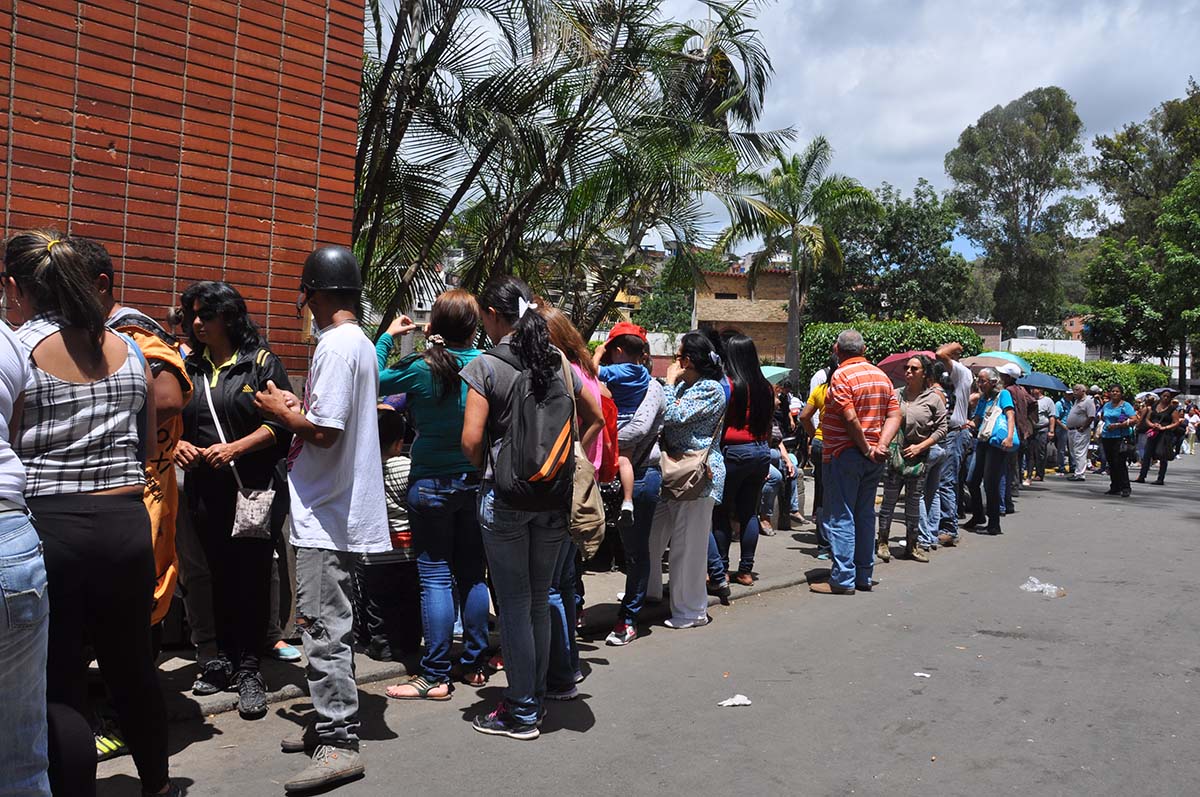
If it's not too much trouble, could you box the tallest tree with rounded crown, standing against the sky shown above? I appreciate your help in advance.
[946,86,1090,334]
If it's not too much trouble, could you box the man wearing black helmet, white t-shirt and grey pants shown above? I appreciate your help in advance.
[254,246,391,793]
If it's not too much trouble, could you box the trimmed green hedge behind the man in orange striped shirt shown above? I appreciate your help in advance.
[800,320,983,384]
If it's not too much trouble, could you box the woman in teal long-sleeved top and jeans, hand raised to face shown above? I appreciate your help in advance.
[376,289,488,700]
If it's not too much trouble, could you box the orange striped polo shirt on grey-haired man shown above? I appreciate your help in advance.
[821,356,900,462]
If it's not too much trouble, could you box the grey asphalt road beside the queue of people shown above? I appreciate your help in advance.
[100,457,1200,797]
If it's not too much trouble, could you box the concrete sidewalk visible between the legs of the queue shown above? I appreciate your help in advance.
[160,474,827,721]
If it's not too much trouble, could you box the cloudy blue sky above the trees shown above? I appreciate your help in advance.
[662,0,1200,257]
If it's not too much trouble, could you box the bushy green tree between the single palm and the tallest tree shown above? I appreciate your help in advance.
[830,179,971,320]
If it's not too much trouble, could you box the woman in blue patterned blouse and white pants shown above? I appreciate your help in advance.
[647,331,726,629]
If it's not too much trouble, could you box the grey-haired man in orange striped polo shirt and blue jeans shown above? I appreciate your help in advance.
[809,329,900,595]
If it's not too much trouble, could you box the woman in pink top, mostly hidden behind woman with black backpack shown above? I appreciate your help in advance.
[538,306,604,700]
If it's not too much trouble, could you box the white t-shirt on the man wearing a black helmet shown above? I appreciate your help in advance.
[288,324,391,553]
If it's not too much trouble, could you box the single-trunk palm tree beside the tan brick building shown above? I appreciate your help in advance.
[718,136,880,382]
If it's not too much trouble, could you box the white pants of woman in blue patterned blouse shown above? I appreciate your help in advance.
[646,498,715,623]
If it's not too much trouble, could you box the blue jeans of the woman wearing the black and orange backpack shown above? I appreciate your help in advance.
[479,483,568,724]
